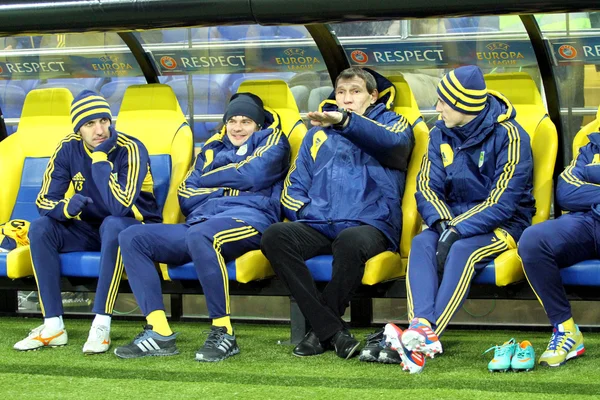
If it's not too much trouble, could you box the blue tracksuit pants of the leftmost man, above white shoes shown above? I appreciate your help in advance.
[29,216,141,318]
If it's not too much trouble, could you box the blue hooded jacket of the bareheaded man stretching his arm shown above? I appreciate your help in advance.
[281,73,414,251]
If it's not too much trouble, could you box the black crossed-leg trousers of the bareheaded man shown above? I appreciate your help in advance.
[261,222,389,342]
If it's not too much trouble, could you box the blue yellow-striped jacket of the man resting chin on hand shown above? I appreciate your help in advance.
[36,127,162,226]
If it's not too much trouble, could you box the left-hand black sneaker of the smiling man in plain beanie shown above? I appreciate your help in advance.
[115,325,179,358]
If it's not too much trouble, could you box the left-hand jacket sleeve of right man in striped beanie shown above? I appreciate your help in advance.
[415,132,454,226]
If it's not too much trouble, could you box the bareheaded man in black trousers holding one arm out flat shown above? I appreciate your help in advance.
[261,67,414,358]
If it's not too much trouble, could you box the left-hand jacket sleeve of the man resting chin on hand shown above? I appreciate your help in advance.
[35,136,75,221]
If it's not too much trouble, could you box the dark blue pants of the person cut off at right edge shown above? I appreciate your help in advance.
[518,211,600,326]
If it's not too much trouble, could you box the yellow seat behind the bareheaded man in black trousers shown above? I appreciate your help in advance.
[362,76,429,285]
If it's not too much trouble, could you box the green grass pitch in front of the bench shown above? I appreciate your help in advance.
[0,318,600,400]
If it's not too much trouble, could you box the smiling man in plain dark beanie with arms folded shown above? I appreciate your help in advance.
[115,93,290,361]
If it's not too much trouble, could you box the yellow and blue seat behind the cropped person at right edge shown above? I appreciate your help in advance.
[560,107,600,286]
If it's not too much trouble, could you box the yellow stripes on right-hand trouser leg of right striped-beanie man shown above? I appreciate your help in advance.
[435,240,508,336]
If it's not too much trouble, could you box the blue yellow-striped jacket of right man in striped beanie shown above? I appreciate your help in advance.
[416,90,535,241]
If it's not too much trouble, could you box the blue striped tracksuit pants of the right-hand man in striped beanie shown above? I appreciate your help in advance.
[406,229,514,336]
